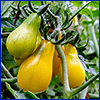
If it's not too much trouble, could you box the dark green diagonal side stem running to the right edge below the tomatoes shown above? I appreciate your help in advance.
[68,73,99,98]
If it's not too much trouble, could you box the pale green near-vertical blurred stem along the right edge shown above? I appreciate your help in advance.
[89,24,99,58]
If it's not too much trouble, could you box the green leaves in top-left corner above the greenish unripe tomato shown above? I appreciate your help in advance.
[1,1,23,32]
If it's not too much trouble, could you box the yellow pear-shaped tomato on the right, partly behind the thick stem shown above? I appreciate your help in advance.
[59,43,85,88]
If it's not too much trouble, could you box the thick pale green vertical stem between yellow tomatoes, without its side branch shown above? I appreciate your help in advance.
[55,45,70,99]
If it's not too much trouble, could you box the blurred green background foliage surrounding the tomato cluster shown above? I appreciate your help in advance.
[1,1,99,99]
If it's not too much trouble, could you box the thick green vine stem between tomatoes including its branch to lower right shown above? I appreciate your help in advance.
[51,45,99,99]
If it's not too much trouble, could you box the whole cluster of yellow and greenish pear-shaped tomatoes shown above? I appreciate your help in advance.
[6,2,85,92]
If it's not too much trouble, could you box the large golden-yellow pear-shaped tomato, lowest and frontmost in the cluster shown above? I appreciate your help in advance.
[17,40,55,92]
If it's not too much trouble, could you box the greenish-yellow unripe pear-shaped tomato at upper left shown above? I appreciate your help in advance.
[6,13,41,59]
